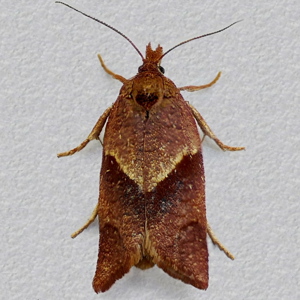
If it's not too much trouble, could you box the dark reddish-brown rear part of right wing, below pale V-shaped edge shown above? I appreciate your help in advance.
[146,152,208,289]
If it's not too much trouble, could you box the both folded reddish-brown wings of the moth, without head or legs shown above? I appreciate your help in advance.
[93,88,208,292]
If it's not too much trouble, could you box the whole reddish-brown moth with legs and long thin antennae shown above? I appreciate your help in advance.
[57,2,244,293]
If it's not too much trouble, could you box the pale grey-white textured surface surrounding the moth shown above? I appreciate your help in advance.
[0,0,300,300]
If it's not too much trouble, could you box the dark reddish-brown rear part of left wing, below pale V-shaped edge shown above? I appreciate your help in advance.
[93,155,145,293]
